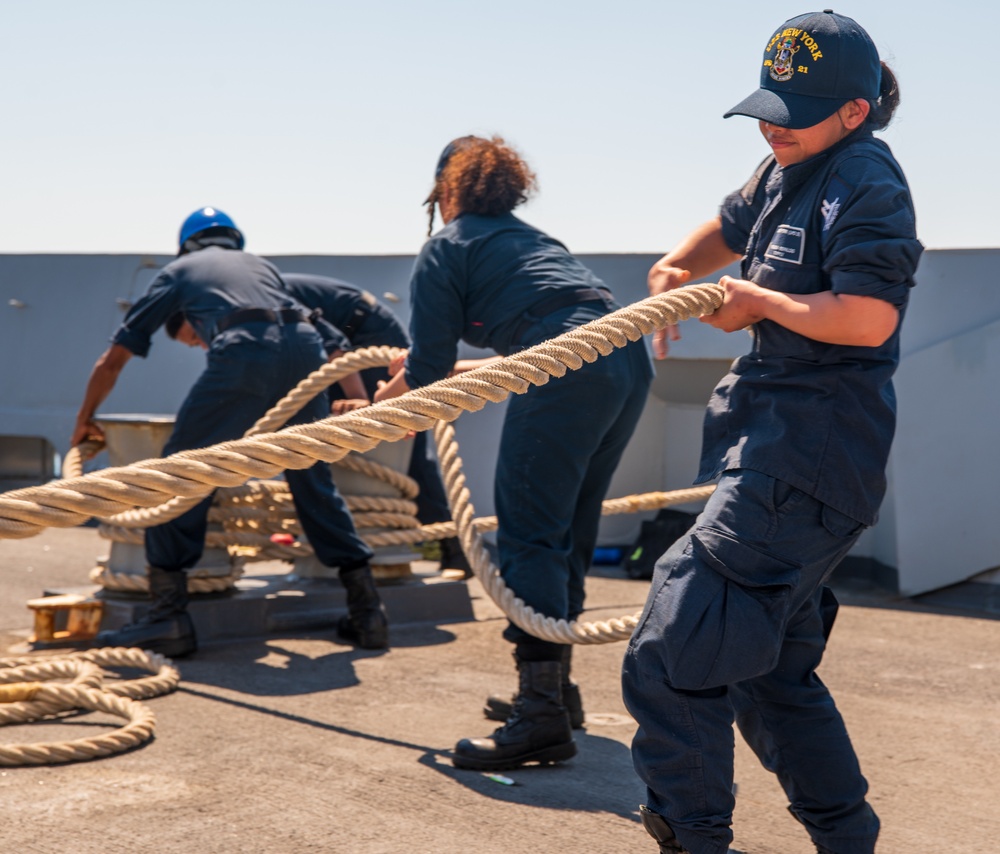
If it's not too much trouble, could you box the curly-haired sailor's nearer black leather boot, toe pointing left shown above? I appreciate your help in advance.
[452,660,576,771]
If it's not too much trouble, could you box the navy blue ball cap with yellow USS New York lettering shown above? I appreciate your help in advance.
[725,9,882,130]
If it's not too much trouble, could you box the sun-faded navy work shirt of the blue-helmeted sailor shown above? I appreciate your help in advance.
[111,246,322,357]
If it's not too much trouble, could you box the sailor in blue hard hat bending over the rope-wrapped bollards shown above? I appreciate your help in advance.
[71,207,389,656]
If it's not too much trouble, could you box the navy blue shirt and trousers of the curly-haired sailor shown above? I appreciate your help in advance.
[405,214,652,646]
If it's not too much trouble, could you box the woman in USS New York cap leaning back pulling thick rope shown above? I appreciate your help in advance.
[622,9,922,854]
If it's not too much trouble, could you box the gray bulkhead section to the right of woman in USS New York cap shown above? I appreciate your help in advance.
[876,249,1000,595]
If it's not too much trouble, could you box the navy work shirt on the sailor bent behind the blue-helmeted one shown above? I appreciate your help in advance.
[281,273,410,352]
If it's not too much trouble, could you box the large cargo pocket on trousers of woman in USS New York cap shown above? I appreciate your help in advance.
[667,528,799,691]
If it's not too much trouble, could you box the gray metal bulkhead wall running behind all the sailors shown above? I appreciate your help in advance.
[0,249,1000,594]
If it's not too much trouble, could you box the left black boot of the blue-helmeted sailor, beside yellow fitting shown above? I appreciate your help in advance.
[94,566,198,658]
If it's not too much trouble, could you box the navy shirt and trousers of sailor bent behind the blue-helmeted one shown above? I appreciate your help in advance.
[281,273,451,525]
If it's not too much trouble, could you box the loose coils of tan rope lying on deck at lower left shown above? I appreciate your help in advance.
[0,648,180,767]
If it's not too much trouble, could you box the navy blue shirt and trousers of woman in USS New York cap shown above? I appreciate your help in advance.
[623,130,922,854]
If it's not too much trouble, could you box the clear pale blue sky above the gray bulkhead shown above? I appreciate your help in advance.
[0,0,1000,254]
